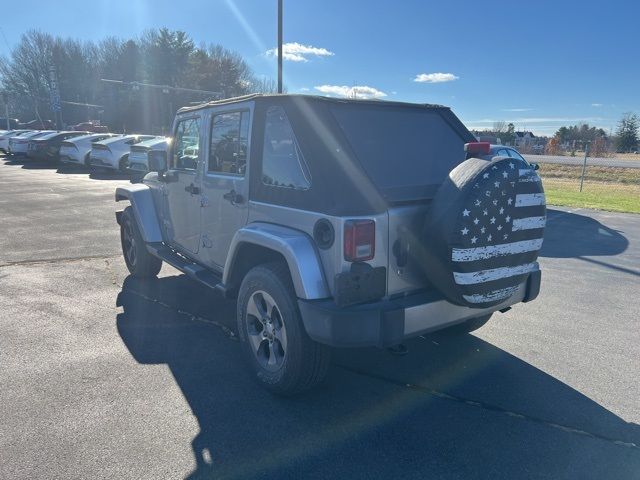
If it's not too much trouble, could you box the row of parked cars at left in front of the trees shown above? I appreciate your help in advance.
[0,130,170,175]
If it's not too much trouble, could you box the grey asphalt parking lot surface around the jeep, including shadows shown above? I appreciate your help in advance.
[0,157,640,479]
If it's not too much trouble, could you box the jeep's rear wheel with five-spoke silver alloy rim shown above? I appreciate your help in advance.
[237,263,330,395]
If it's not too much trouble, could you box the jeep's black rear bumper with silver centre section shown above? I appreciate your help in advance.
[298,270,541,347]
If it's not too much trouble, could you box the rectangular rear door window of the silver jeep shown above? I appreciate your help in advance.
[207,111,249,175]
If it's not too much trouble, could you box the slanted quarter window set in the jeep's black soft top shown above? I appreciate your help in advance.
[262,107,311,190]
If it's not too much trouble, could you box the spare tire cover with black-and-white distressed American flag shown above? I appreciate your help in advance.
[420,157,546,308]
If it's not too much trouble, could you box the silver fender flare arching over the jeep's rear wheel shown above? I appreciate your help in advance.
[222,222,331,300]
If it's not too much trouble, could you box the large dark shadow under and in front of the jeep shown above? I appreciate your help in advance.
[116,275,640,479]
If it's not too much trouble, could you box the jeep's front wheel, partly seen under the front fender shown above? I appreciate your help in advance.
[120,207,162,278]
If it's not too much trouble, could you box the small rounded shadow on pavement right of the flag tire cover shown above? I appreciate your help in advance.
[541,208,629,258]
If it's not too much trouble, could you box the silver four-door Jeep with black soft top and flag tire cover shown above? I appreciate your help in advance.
[116,95,545,394]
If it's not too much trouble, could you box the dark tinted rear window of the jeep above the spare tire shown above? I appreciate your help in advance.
[330,104,465,200]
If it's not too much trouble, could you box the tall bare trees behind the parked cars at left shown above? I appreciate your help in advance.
[0,28,275,133]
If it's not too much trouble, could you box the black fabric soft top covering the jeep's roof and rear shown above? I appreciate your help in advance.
[178,94,474,216]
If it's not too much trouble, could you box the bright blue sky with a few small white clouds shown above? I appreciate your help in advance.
[0,0,640,135]
